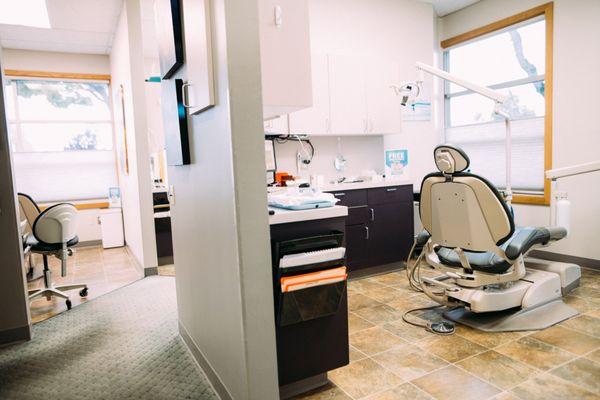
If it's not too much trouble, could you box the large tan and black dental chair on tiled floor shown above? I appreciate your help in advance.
[411,145,581,332]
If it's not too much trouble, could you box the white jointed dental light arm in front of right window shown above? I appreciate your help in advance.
[392,62,512,204]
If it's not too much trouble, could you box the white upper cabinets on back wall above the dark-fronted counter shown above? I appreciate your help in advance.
[289,54,401,136]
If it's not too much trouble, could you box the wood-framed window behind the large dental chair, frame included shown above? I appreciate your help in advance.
[442,3,552,204]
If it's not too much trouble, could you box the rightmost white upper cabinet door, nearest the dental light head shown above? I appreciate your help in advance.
[366,60,401,134]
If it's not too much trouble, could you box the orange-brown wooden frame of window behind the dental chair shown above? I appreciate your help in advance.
[440,2,554,206]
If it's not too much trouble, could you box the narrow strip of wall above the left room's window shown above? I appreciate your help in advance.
[2,49,110,74]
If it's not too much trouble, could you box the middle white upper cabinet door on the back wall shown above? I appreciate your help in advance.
[329,56,367,135]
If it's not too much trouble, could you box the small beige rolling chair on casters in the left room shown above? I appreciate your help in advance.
[18,193,88,310]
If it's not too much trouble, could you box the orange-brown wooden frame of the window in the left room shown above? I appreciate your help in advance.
[4,69,118,210]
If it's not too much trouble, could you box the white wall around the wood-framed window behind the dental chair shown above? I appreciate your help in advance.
[439,0,600,260]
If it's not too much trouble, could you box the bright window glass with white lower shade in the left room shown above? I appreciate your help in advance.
[5,77,117,202]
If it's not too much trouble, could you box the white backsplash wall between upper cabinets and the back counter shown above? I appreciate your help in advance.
[275,136,384,180]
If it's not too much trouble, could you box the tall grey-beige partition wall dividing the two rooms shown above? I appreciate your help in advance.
[168,0,278,400]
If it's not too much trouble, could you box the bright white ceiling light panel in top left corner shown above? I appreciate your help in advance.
[0,0,50,28]
